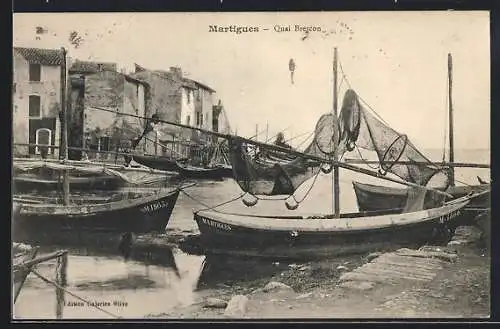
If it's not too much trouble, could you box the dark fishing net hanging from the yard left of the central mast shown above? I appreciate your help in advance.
[229,114,339,196]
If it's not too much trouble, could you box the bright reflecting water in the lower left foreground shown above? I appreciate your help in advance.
[14,246,204,319]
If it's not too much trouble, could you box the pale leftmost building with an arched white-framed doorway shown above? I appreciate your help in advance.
[12,47,64,157]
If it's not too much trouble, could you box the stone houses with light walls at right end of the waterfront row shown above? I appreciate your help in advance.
[131,64,229,156]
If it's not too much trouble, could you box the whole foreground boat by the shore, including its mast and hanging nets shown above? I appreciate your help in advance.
[188,51,489,259]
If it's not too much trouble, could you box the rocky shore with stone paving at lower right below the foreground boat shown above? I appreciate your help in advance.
[147,227,491,319]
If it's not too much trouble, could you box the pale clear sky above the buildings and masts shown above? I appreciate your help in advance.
[13,11,490,149]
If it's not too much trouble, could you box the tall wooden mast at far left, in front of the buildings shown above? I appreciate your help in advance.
[59,47,69,205]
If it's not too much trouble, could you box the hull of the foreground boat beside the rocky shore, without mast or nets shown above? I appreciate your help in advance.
[194,192,471,259]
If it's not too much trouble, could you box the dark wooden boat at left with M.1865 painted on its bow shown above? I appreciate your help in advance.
[13,189,179,239]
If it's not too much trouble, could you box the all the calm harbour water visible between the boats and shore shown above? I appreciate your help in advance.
[14,151,490,319]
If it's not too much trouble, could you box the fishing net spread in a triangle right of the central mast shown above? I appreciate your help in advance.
[339,89,448,208]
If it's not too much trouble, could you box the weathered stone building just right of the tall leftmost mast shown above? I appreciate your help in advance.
[70,70,149,159]
